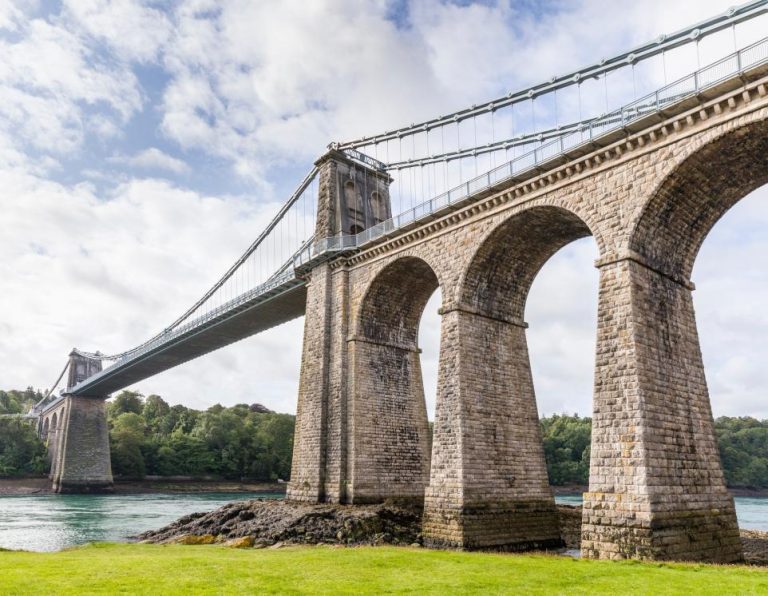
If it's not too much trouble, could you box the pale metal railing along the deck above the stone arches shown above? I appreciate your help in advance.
[302,37,768,266]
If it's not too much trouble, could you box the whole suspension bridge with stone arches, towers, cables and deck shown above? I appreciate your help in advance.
[35,0,768,560]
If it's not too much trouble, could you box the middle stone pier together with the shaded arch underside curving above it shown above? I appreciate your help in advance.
[424,205,591,549]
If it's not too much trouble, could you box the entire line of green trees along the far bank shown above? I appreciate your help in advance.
[0,388,768,488]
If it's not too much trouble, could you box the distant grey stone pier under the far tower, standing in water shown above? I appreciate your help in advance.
[52,395,113,493]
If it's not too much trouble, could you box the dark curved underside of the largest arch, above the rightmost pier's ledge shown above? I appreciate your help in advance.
[629,120,768,280]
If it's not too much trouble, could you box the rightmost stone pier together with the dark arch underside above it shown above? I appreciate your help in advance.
[582,120,768,562]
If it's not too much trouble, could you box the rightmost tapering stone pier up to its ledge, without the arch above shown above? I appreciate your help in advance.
[582,258,742,563]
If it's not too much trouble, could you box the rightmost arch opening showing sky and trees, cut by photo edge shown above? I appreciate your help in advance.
[693,185,768,494]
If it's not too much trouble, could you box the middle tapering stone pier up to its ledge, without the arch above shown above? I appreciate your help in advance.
[423,308,562,550]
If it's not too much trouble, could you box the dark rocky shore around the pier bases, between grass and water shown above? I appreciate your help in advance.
[136,499,768,565]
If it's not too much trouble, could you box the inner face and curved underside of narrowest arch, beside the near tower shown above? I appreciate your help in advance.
[347,256,439,503]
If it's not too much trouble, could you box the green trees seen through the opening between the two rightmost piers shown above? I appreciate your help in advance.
[541,414,592,486]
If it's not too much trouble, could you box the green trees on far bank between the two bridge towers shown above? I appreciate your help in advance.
[108,391,295,480]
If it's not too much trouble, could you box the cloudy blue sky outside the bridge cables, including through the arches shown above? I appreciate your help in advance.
[0,0,768,417]
